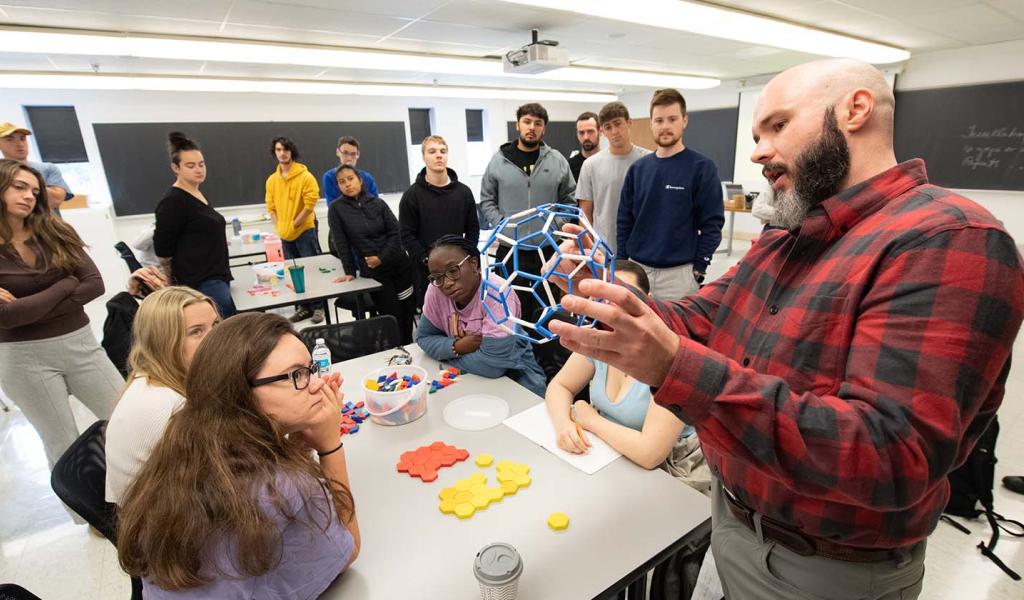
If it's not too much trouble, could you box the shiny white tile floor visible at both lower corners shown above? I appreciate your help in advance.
[0,242,1024,600]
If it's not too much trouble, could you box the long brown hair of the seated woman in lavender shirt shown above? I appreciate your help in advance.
[118,313,355,590]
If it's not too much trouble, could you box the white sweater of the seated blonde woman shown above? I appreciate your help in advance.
[105,377,185,504]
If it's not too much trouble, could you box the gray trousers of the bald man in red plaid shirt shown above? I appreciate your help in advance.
[711,477,926,600]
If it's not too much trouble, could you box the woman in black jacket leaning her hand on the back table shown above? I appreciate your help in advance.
[327,165,416,344]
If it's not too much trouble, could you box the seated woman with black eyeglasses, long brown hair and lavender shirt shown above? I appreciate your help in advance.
[118,313,359,599]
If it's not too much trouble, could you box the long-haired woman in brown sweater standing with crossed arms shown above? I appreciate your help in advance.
[0,160,124,467]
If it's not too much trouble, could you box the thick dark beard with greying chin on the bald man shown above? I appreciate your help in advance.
[775,106,850,229]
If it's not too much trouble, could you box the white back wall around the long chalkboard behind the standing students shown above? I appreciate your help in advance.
[0,89,600,301]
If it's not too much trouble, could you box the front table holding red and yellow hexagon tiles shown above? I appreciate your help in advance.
[322,344,711,600]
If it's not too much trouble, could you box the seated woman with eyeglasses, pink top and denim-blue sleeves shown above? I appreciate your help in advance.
[416,235,547,397]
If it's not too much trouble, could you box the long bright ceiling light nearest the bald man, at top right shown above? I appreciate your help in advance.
[502,0,910,65]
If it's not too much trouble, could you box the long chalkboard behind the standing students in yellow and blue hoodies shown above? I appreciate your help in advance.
[93,121,410,216]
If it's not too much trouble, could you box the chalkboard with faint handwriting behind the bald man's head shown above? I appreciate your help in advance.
[894,81,1024,190]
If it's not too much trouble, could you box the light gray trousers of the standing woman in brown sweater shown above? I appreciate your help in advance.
[0,326,125,468]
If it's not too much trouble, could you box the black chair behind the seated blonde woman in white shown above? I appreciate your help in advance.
[51,421,142,600]
